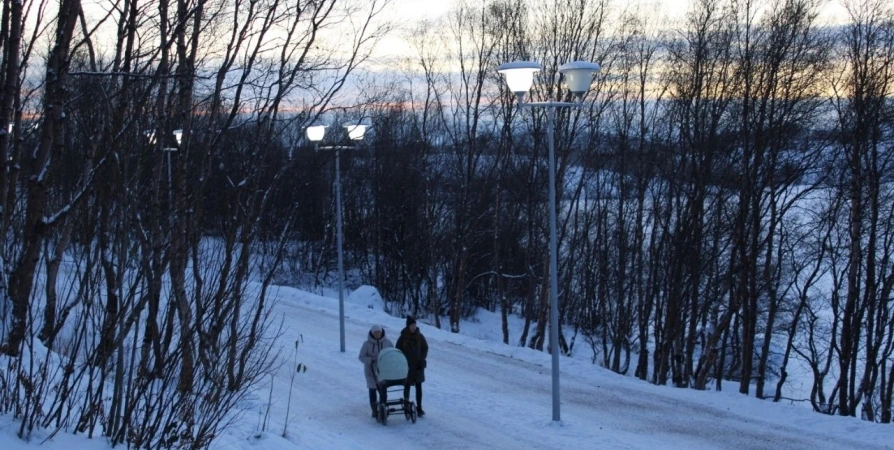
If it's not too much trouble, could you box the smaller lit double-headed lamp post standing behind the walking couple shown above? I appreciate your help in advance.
[305,124,366,353]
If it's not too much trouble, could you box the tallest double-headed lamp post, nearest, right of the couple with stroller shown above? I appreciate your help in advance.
[497,57,599,422]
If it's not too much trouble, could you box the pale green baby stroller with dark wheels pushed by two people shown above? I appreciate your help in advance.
[373,347,416,425]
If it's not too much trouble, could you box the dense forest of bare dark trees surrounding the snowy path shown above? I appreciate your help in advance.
[0,0,894,448]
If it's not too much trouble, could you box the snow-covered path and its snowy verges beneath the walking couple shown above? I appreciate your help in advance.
[0,287,894,450]
